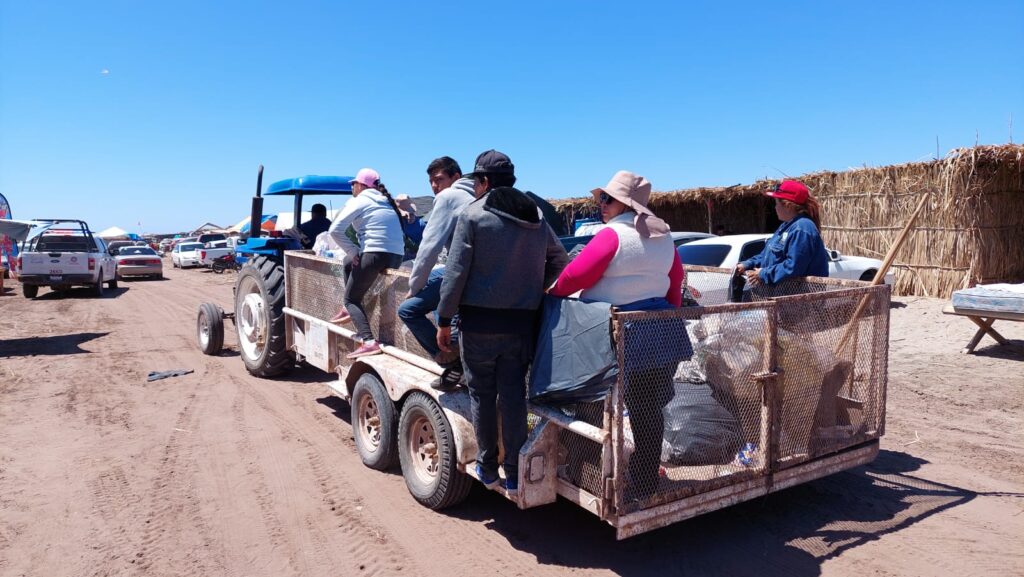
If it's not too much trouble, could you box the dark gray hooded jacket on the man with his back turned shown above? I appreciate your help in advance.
[437,187,568,333]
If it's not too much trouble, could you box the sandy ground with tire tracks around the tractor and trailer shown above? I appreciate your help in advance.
[0,267,1024,577]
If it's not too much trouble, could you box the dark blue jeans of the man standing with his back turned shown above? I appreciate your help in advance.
[460,332,534,480]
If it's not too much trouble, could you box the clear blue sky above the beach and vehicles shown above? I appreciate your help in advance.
[0,0,1024,233]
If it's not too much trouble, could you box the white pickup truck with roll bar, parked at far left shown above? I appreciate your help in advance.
[17,218,118,298]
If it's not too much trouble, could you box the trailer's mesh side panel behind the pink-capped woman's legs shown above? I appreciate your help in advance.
[285,252,430,359]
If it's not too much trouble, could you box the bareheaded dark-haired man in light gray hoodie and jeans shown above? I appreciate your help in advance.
[398,156,476,365]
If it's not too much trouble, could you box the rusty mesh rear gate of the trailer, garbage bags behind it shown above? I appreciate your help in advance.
[611,269,889,513]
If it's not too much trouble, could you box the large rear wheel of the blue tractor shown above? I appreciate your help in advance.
[234,255,294,377]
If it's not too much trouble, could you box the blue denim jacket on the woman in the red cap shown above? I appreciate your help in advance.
[743,214,828,285]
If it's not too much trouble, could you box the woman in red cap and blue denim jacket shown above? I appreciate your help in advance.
[736,180,828,287]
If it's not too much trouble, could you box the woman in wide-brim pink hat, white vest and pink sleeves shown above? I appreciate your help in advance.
[549,170,692,498]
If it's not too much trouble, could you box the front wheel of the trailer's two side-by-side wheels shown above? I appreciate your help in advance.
[351,373,398,470]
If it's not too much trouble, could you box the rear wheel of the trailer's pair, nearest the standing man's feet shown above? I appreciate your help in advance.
[398,393,472,510]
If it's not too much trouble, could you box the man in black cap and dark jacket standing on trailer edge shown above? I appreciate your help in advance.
[437,151,568,493]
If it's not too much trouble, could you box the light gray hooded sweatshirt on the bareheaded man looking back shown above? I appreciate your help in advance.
[409,178,476,295]
